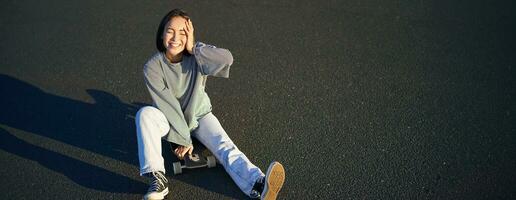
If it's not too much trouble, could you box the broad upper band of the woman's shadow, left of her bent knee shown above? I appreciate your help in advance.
[0,74,138,165]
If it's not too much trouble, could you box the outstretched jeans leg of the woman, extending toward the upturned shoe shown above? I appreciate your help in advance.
[192,113,264,195]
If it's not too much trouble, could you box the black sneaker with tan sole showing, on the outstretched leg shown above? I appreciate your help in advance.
[250,162,285,200]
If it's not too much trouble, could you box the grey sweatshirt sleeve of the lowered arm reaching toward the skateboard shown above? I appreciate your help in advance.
[144,63,192,146]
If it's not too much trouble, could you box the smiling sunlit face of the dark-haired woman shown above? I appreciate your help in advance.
[163,17,187,57]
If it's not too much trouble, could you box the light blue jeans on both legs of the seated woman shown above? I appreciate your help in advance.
[136,106,264,195]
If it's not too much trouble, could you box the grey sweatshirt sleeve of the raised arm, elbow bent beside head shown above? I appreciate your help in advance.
[193,42,233,78]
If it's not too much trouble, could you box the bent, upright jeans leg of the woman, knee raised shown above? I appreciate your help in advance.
[136,106,170,175]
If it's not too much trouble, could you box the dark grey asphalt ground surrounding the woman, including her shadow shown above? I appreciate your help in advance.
[0,0,516,199]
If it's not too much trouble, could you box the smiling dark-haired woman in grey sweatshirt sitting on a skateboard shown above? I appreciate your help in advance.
[136,9,285,199]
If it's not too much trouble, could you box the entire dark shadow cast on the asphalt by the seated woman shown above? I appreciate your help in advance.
[0,74,250,199]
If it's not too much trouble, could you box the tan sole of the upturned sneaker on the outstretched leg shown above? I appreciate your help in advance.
[261,162,285,200]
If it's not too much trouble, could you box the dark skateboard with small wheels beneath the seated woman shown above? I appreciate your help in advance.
[172,145,217,175]
